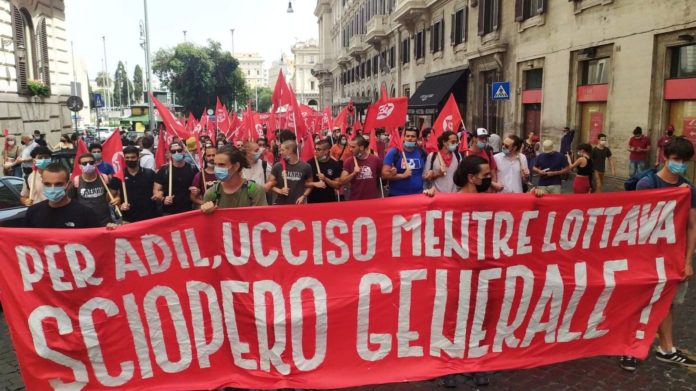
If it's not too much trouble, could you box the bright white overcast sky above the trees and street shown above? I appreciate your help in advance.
[65,0,318,79]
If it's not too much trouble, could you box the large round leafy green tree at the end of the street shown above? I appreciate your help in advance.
[152,40,249,113]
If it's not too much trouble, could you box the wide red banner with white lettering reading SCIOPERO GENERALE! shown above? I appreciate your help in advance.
[0,189,689,390]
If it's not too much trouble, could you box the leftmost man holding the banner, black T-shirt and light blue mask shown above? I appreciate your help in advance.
[24,163,101,228]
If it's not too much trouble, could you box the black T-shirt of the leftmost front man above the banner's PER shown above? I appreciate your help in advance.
[24,200,102,228]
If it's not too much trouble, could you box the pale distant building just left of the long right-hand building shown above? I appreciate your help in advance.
[290,40,319,109]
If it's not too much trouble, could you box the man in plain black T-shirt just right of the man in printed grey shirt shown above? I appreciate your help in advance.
[119,146,158,223]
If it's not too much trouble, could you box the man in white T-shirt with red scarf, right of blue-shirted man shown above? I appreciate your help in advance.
[423,130,462,193]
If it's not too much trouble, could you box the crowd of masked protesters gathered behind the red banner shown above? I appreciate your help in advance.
[4,123,696,386]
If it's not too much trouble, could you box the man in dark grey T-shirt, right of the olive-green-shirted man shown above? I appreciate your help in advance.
[266,140,312,205]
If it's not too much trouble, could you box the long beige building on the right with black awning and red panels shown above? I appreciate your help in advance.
[314,0,696,177]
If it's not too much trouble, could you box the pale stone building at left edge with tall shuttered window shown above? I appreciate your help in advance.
[0,0,73,144]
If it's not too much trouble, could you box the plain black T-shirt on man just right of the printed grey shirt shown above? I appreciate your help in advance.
[121,167,158,222]
